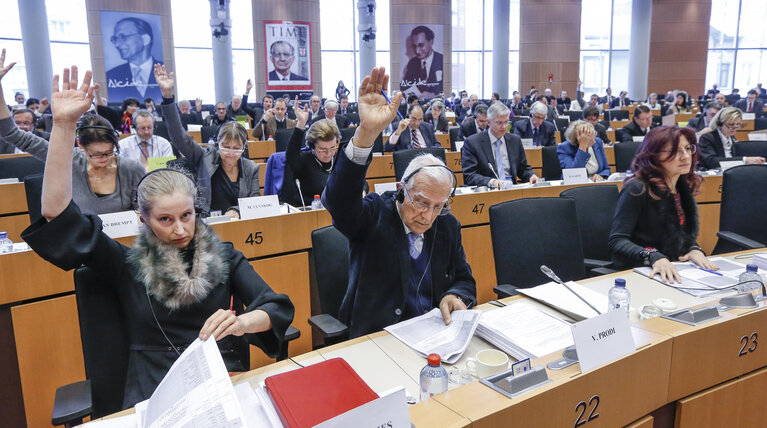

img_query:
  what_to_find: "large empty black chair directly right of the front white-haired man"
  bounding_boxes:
[489,198,586,298]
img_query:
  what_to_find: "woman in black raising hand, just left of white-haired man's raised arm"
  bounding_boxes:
[285,101,341,206]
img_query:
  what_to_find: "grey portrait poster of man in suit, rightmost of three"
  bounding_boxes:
[399,24,444,99]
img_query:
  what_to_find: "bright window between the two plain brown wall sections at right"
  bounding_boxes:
[580,0,631,99]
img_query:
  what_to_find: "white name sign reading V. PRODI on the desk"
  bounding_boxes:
[571,310,636,373]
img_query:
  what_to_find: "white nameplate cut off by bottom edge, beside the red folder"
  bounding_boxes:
[315,386,411,428]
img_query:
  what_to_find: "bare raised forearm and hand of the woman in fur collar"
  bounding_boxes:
[41,65,96,221]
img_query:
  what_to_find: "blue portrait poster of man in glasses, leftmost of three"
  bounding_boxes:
[100,10,163,103]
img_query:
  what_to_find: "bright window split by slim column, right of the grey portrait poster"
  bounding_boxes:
[446,0,519,98]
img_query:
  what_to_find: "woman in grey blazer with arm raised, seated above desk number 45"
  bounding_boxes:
[154,64,261,218]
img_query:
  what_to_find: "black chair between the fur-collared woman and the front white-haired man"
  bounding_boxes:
[309,226,349,345]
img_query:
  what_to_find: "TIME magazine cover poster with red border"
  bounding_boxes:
[264,21,312,93]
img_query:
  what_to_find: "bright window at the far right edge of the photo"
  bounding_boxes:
[706,0,767,96]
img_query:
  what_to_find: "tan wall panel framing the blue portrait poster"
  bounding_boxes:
[84,0,176,97]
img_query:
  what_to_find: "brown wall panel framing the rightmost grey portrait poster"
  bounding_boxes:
[390,0,450,94]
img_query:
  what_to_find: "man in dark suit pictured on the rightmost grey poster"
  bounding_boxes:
[400,25,443,98]
